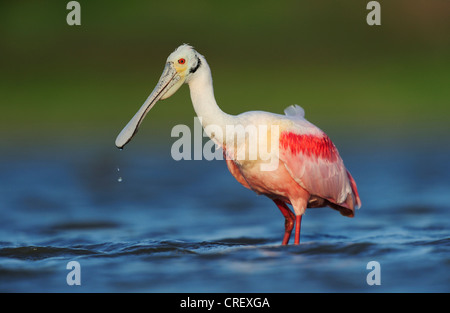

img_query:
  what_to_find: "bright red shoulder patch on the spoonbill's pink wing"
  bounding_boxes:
[280,132,339,162]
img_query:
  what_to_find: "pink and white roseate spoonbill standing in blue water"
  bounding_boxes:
[115,44,361,245]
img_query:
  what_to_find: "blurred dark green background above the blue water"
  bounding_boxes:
[0,0,450,145]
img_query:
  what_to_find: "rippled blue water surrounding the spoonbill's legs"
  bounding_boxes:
[0,138,450,292]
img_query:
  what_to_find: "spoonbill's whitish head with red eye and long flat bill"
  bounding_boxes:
[116,44,205,148]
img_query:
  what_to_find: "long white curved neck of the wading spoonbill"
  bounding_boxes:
[188,58,235,146]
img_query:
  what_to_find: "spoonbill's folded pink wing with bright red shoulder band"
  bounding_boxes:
[280,128,361,216]
